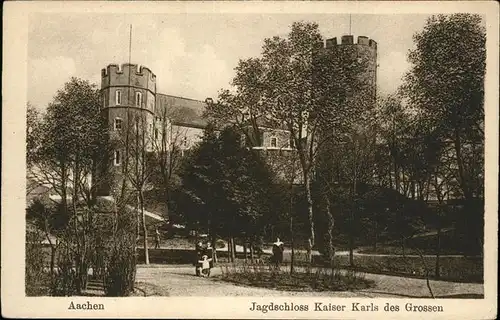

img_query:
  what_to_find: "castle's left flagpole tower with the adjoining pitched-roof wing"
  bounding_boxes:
[97,64,291,196]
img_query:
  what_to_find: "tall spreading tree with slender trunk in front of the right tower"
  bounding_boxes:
[206,22,375,262]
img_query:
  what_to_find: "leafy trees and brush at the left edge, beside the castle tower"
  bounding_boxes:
[27,78,135,296]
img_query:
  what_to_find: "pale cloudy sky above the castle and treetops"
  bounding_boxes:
[27,13,429,109]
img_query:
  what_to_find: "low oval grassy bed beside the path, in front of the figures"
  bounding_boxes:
[218,264,374,292]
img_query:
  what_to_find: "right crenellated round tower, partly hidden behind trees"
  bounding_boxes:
[315,35,377,186]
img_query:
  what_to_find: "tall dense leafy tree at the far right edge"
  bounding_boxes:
[402,14,486,255]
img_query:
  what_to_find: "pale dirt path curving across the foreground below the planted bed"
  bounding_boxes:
[136,265,483,298]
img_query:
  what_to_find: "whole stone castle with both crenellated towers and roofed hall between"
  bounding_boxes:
[99,35,377,195]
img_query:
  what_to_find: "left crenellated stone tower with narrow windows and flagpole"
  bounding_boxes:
[98,64,156,196]
